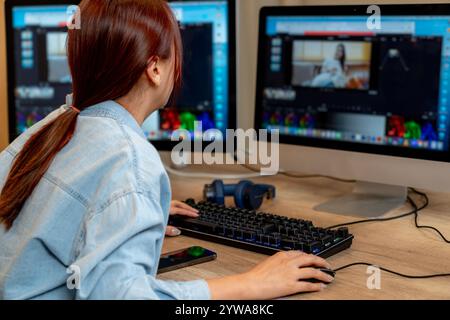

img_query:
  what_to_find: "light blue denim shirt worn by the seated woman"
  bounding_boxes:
[0,101,210,300]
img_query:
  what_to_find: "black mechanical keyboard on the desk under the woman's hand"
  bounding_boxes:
[169,199,353,258]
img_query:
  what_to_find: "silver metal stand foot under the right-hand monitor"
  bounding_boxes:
[314,181,408,218]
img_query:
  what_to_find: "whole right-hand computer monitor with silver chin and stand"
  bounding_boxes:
[255,4,450,216]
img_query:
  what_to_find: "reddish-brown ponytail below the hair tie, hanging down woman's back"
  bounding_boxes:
[0,108,79,230]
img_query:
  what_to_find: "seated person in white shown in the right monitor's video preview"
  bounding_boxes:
[311,43,347,88]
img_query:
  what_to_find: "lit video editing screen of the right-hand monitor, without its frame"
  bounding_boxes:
[260,16,450,152]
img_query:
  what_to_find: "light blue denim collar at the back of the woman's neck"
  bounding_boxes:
[80,100,147,140]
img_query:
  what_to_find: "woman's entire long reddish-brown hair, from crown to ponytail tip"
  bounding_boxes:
[0,0,182,229]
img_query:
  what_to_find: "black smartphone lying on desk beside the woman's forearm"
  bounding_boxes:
[158,246,217,274]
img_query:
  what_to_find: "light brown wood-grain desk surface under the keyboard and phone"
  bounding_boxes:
[161,167,450,299]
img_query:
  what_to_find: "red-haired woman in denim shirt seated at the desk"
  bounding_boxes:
[0,0,332,299]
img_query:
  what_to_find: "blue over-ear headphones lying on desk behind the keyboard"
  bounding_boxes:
[203,180,275,210]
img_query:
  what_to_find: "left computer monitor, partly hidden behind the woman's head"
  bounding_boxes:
[6,0,236,150]
